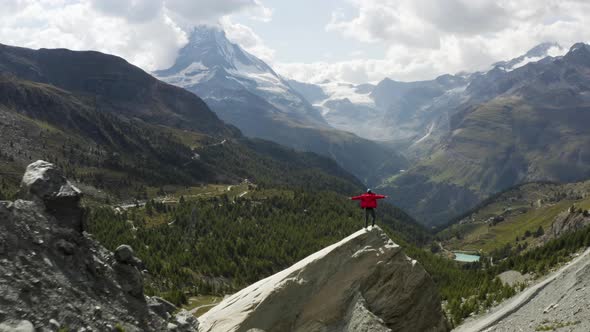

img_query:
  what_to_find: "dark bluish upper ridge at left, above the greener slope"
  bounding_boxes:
[0,45,237,137]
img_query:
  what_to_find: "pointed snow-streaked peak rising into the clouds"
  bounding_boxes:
[154,25,327,127]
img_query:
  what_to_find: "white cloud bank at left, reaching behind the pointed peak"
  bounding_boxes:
[0,0,272,70]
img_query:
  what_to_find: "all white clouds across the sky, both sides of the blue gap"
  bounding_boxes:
[0,0,590,83]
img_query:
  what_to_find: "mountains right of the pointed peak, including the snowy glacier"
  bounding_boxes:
[293,43,590,225]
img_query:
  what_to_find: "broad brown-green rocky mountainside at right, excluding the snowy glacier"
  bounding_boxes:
[384,44,590,224]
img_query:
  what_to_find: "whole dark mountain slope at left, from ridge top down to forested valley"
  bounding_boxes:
[0,41,362,198]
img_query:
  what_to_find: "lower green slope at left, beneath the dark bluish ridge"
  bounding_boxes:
[0,68,362,199]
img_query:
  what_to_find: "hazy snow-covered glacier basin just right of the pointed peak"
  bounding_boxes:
[290,75,469,151]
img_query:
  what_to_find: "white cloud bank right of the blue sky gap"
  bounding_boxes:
[284,0,590,83]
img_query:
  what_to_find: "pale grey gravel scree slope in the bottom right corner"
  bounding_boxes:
[454,249,590,332]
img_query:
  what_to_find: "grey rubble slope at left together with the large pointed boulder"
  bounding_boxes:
[0,161,449,332]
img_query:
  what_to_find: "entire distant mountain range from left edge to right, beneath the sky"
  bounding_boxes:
[0,27,590,231]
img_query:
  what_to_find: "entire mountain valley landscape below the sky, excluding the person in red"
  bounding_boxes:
[0,9,590,332]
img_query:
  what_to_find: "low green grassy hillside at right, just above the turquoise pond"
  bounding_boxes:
[438,182,590,253]
